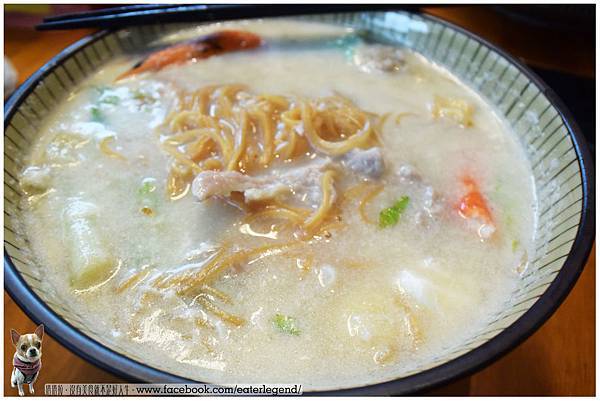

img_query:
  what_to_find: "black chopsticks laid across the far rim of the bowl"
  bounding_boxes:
[36,4,419,30]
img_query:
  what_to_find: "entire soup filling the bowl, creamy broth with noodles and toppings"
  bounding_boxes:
[20,20,536,390]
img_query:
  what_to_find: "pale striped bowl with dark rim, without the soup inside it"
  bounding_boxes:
[4,12,595,394]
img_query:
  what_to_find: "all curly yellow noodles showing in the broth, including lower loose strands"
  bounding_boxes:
[146,85,385,310]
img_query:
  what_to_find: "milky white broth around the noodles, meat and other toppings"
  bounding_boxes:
[20,21,536,390]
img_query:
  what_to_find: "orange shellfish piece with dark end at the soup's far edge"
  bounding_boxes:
[117,30,262,81]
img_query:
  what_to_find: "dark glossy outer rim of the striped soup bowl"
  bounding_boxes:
[4,11,595,395]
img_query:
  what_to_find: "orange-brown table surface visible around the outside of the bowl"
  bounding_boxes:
[4,7,596,395]
